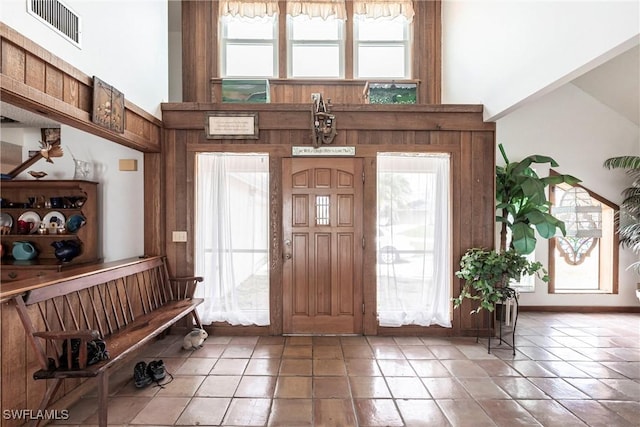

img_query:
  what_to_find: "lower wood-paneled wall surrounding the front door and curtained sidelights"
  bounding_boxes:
[163,103,495,335]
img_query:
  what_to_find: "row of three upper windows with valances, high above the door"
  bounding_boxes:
[219,0,413,79]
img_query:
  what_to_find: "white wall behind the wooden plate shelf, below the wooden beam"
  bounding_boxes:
[11,126,144,261]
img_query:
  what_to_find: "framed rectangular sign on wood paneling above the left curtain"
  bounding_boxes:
[205,111,259,139]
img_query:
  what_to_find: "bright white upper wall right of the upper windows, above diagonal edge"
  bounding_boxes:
[442,0,640,121]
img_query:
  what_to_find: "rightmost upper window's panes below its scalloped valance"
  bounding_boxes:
[353,15,411,79]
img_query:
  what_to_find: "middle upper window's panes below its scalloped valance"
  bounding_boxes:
[287,15,344,78]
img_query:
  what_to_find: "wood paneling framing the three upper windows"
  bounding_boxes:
[182,0,441,104]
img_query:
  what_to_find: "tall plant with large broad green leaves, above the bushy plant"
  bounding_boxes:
[496,144,580,255]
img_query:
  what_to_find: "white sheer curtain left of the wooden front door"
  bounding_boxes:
[195,153,269,325]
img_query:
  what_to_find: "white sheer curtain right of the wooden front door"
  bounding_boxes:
[377,153,452,327]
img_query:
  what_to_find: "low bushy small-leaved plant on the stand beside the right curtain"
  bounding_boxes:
[453,248,549,313]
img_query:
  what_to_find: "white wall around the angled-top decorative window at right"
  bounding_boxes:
[496,84,640,306]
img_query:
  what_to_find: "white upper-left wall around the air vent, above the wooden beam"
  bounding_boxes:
[0,0,169,118]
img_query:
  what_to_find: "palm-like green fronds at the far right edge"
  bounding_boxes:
[604,156,640,274]
